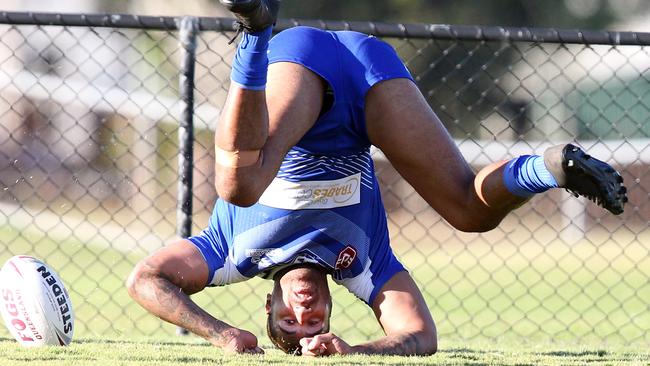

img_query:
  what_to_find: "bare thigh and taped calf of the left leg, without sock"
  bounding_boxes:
[215,62,324,206]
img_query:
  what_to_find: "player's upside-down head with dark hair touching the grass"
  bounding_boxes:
[266,266,332,354]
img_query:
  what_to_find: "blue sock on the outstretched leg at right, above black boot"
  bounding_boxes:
[503,155,558,198]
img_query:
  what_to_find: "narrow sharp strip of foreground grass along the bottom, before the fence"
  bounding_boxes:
[0,338,650,366]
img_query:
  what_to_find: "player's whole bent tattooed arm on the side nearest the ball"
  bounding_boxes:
[127,240,262,353]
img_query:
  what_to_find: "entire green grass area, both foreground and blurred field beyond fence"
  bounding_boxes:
[0,213,650,365]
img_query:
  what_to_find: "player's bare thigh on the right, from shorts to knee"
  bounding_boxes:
[366,79,474,216]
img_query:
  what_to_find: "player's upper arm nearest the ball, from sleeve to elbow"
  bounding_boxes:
[136,239,208,294]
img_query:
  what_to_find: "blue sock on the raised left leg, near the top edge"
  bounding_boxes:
[230,26,273,90]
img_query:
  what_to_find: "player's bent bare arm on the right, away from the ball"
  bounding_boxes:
[301,271,438,356]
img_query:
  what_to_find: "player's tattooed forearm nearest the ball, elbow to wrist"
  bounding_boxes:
[134,264,232,346]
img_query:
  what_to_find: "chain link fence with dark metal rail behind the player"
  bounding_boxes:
[0,13,650,344]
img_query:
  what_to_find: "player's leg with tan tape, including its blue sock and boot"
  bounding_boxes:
[215,0,324,206]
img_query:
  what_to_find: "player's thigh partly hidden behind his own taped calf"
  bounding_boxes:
[265,62,325,154]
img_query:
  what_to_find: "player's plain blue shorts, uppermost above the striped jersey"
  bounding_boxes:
[268,27,413,154]
